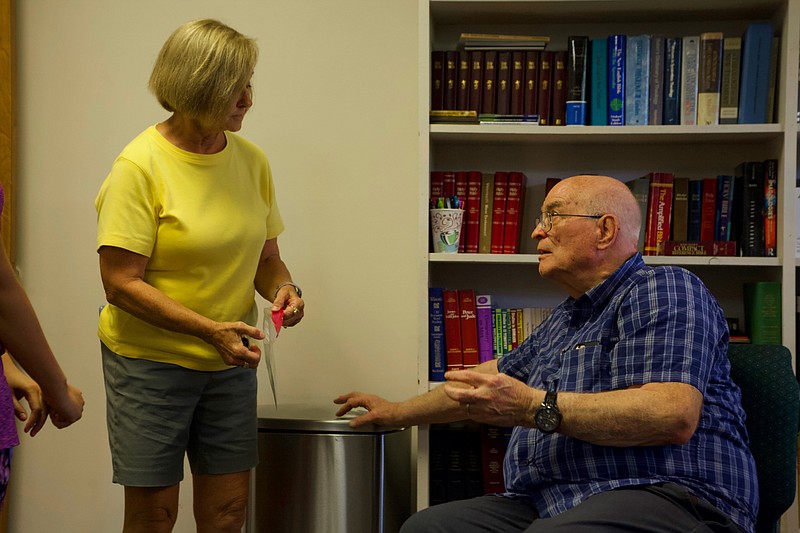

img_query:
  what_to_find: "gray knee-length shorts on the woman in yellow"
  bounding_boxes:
[101,343,258,487]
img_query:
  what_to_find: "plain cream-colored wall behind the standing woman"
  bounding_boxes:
[10,0,424,533]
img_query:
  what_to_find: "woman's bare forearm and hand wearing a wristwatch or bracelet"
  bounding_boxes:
[255,238,305,327]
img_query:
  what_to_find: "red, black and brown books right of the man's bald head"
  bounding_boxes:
[628,159,778,257]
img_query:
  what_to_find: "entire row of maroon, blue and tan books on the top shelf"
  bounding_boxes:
[431,22,779,126]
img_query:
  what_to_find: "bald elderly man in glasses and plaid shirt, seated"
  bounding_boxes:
[335,176,758,533]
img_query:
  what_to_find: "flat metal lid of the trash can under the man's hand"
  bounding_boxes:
[258,403,405,434]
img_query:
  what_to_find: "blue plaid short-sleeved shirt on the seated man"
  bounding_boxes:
[498,254,758,531]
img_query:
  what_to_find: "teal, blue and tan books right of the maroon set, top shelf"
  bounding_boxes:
[592,23,779,126]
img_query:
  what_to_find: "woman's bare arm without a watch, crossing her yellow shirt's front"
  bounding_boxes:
[98,246,263,367]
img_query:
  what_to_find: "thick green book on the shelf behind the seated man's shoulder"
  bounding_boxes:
[744,281,783,344]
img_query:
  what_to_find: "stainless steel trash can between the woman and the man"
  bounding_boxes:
[247,404,412,533]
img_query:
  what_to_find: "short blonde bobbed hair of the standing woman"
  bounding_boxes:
[148,19,258,122]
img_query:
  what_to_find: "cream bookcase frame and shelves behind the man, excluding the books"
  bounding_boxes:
[417,0,800,533]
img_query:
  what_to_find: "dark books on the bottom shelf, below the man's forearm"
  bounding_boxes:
[429,423,511,505]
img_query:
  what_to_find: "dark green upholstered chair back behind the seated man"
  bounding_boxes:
[728,344,800,533]
